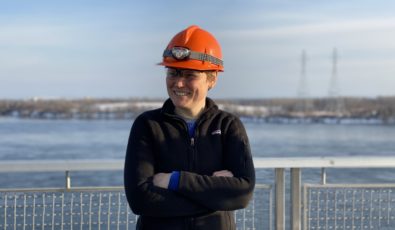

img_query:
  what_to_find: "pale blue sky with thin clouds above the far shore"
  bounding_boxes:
[0,0,395,98]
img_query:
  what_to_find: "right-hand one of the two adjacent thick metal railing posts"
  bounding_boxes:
[291,168,302,230]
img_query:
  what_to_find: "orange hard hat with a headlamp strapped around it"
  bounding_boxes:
[159,25,224,71]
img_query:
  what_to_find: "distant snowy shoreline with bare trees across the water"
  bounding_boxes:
[0,96,395,123]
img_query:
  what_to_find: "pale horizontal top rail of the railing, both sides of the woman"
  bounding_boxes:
[0,156,395,172]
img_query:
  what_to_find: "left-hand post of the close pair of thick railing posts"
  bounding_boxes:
[275,168,285,230]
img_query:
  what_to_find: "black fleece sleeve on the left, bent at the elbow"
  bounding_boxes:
[124,117,208,217]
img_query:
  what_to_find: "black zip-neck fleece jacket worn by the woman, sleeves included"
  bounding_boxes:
[124,98,255,230]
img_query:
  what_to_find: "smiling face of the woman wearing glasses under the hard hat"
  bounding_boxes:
[166,68,216,114]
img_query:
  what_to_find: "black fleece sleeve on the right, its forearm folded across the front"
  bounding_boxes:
[177,118,255,210]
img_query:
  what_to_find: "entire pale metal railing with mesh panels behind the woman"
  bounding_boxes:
[0,157,395,230]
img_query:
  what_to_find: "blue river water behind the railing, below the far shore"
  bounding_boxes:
[0,118,395,187]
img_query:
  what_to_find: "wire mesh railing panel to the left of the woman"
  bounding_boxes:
[0,188,136,230]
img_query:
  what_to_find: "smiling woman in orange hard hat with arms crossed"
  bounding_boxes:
[124,26,255,230]
